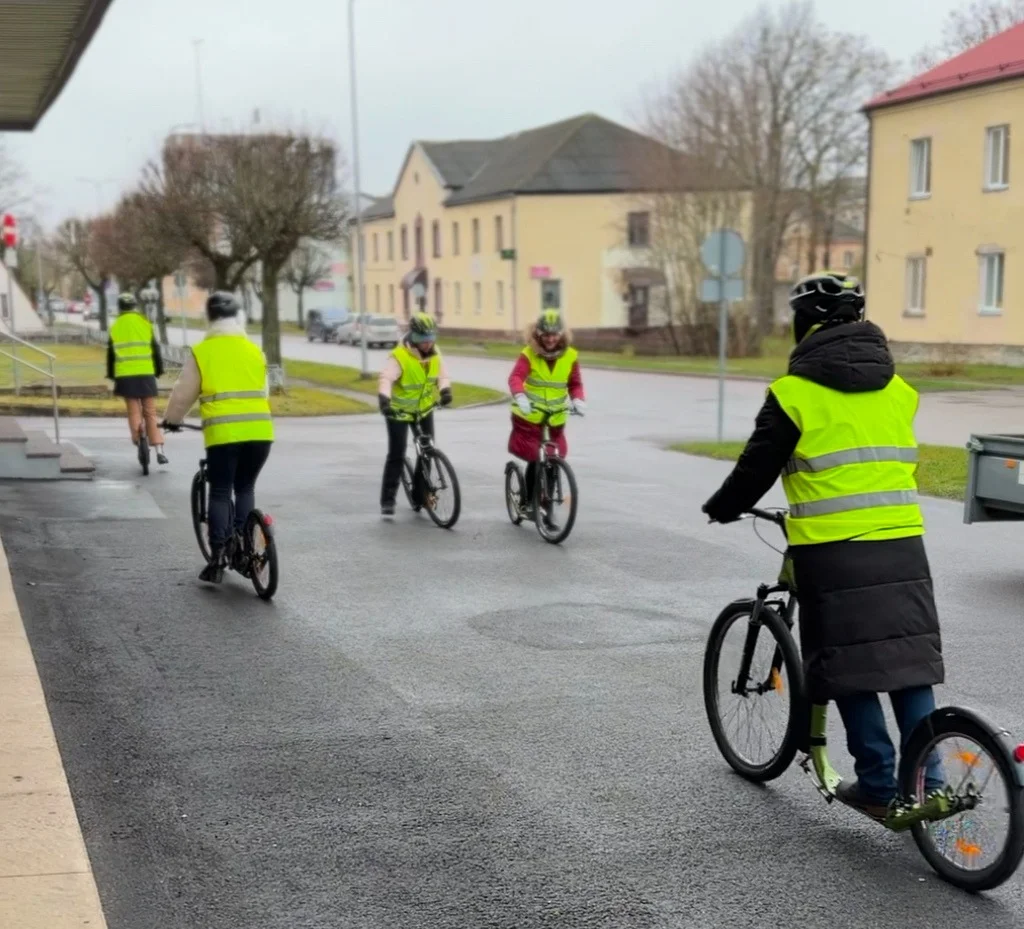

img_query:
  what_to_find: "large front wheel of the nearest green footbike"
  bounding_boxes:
[703,600,806,784]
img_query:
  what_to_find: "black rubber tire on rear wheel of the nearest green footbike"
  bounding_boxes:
[900,707,1024,893]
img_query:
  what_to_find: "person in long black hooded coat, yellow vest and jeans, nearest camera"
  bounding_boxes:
[703,271,944,819]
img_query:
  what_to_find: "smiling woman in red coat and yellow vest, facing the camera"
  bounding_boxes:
[508,309,587,517]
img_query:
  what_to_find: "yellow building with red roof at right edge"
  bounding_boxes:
[864,24,1024,364]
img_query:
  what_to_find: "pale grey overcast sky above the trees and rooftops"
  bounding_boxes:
[7,0,959,225]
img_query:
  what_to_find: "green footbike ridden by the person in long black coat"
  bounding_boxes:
[703,509,1024,892]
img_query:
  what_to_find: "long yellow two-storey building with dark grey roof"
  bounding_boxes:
[362,114,724,337]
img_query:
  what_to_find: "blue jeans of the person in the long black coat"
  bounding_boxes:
[836,687,945,803]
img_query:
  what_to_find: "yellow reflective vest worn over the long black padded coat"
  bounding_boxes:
[769,375,924,545]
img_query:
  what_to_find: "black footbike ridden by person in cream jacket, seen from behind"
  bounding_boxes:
[171,423,279,600]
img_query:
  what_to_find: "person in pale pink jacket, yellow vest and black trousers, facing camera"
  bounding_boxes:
[377,312,452,517]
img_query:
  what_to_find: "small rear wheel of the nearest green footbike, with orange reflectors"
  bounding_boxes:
[900,707,1024,892]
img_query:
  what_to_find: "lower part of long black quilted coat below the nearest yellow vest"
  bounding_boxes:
[790,536,944,703]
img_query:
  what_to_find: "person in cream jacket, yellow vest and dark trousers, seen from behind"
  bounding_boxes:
[164,292,273,584]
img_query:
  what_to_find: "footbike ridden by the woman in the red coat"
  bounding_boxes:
[505,407,581,545]
